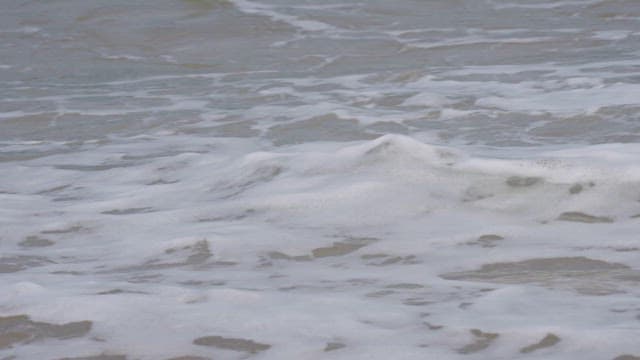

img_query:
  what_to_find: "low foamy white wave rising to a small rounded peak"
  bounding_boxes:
[211,135,640,222]
